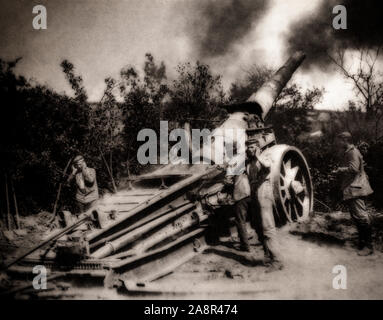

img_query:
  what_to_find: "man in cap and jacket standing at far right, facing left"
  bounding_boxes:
[333,132,374,256]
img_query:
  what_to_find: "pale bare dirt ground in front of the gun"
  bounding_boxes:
[0,212,383,299]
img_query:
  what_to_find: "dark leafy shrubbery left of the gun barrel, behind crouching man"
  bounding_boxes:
[0,54,226,214]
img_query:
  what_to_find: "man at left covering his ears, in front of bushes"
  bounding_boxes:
[68,155,98,214]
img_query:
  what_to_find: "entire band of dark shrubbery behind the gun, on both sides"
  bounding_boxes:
[0,54,383,218]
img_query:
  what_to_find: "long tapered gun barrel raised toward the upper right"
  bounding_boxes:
[246,51,306,120]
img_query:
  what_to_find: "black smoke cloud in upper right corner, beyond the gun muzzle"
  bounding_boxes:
[287,0,383,67]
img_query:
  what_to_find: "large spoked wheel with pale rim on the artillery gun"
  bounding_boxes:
[266,145,313,222]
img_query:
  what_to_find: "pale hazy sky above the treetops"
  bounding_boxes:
[0,0,353,109]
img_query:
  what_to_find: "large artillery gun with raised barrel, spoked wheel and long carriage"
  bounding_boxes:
[7,52,313,291]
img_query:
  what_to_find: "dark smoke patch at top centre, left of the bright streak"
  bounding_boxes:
[193,0,269,58]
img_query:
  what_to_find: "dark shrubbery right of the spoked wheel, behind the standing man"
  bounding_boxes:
[273,110,383,210]
